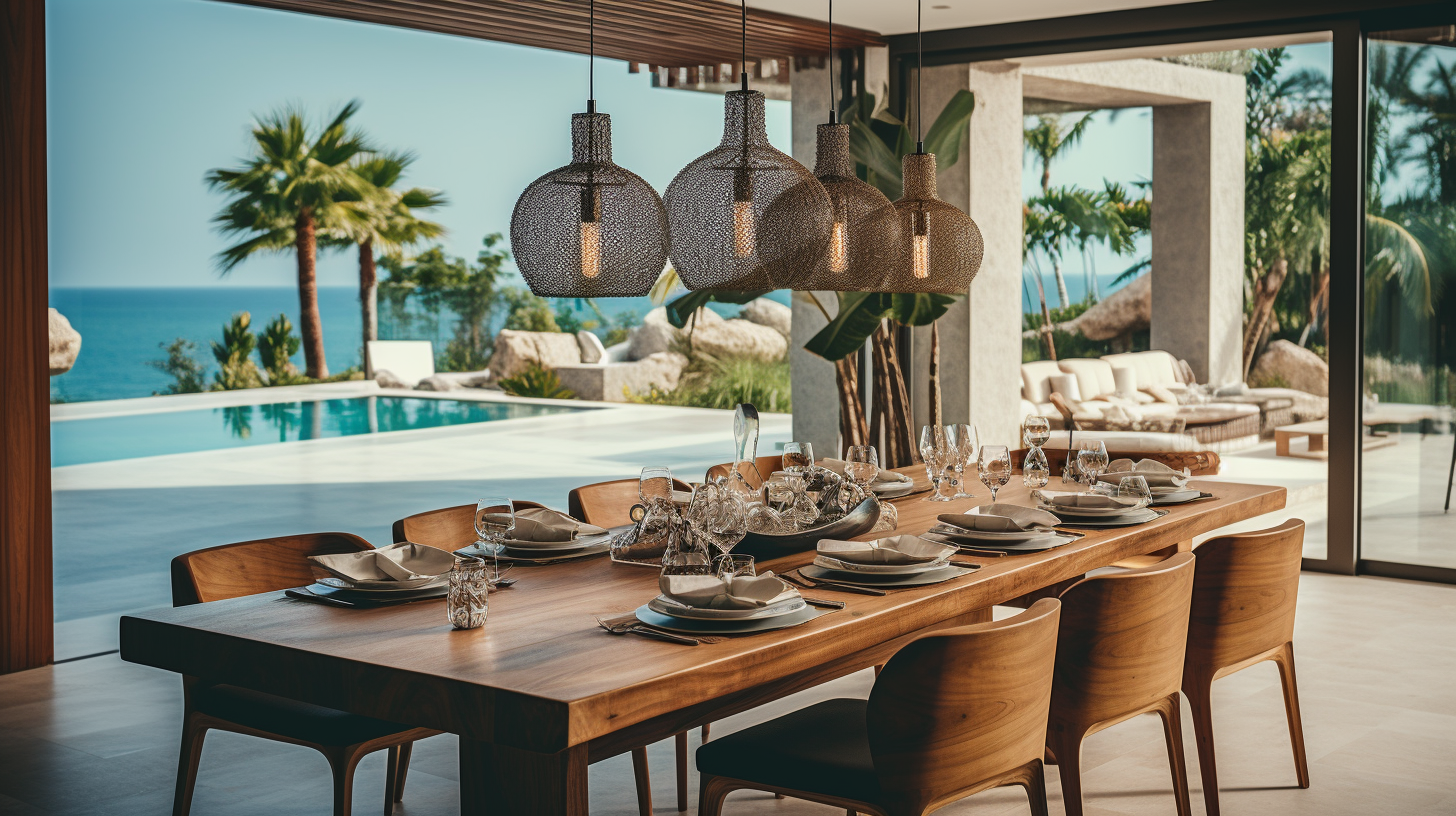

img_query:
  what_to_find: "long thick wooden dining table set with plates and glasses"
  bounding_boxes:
[121,469,1286,816]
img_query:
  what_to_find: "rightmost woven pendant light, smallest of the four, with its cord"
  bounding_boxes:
[884,0,984,294]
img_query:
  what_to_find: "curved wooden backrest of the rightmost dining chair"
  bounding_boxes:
[1187,519,1305,669]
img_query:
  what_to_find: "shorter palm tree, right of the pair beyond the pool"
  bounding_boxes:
[329,153,447,377]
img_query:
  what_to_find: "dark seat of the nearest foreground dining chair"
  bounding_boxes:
[697,699,879,804]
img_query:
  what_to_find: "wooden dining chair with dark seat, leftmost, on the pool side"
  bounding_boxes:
[172,533,440,816]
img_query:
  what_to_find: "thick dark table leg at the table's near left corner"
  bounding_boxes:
[460,737,588,816]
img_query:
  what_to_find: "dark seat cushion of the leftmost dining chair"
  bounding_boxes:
[192,685,412,746]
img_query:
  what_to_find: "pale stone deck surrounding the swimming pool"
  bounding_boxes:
[51,382,791,660]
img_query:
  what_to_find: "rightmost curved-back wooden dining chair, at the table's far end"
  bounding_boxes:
[1182,519,1309,816]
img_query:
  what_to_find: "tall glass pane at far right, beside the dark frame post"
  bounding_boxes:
[1360,28,1456,568]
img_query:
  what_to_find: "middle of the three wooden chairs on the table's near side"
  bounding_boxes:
[1047,552,1194,816]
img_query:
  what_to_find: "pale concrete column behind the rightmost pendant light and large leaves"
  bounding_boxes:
[906,63,1022,447]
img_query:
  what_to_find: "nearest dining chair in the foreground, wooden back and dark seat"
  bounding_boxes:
[697,597,1061,816]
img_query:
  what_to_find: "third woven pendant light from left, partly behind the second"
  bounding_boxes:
[792,0,900,291]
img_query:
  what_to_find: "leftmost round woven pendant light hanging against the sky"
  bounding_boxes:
[511,0,667,297]
